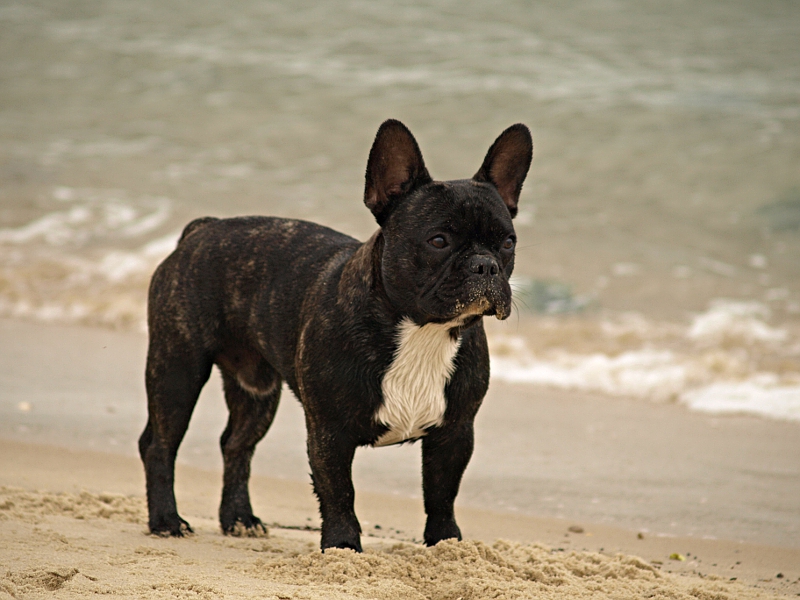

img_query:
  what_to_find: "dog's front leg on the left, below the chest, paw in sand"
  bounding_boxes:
[308,422,361,552]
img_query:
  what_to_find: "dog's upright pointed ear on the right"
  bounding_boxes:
[472,123,533,218]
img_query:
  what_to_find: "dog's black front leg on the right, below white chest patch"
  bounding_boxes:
[422,422,474,546]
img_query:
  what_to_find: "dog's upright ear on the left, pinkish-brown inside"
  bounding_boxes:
[364,119,433,226]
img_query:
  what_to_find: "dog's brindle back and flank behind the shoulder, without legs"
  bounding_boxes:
[148,217,359,377]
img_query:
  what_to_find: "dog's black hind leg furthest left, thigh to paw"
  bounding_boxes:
[139,344,212,536]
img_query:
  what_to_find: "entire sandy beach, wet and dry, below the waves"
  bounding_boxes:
[0,321,800,598]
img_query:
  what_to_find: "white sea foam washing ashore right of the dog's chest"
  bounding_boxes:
[490,299,800,421]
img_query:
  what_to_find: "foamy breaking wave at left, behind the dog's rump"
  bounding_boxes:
[0,186,179,329]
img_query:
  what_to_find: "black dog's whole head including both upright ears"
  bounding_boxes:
[364,120,533,325]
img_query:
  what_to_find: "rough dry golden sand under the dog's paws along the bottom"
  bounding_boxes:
[0,442,800,600]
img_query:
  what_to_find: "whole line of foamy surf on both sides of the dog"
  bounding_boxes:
[0,186,800,420]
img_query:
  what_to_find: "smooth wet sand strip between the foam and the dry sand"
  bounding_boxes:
[0,320,800,547]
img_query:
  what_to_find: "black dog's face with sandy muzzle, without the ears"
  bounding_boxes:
[382,180,516,324]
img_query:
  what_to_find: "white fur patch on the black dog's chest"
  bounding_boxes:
[374,319,461,446]
